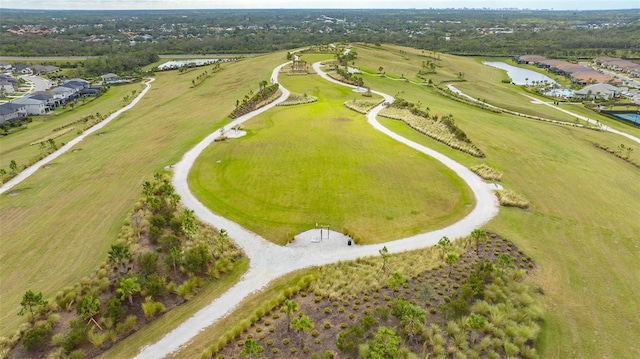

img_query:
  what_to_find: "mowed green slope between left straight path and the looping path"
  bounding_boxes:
[0,53,285,335]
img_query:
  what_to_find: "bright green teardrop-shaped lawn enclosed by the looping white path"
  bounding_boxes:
[189,71,474,244]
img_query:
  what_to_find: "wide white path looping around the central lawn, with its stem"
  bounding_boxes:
[136,63,498,358]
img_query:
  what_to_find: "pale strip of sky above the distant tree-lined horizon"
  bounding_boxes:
[0,0,640,10]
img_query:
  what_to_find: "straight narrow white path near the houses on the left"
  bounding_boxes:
[0,78,156,194]
